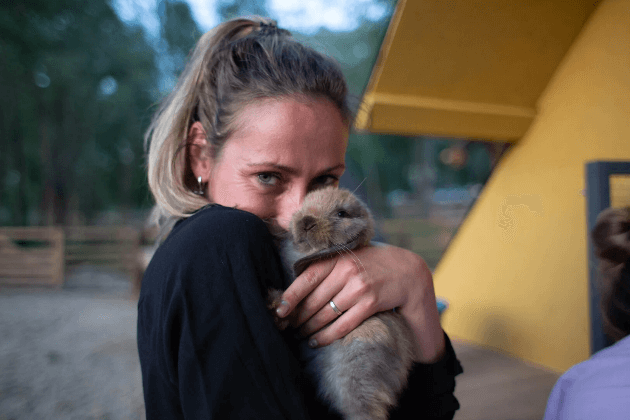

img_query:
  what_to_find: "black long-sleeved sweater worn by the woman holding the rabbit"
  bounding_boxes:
[138,205,462,420]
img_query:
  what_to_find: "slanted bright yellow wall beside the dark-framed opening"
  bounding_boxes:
[435,0,630,370]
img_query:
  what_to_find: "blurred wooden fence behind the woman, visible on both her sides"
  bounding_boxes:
[0,219,454,293]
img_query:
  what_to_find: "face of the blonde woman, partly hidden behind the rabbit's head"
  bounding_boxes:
[199,98,348,230]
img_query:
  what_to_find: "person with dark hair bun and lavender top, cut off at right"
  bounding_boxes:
[545,208,630,420]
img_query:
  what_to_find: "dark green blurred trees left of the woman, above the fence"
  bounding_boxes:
[0,0,157,225]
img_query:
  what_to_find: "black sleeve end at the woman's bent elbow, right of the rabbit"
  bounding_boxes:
[390,333,464,420]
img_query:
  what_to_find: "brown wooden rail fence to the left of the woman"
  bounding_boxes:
[0,226,140,287]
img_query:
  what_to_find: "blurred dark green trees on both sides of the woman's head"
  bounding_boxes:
[0,0,498,225]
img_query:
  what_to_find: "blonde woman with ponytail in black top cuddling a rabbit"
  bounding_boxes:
[138,18,461,420]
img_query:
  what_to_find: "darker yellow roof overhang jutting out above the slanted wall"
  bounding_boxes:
[355,0,597,141]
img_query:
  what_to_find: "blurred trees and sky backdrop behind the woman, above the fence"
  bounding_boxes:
[0,0,504,267]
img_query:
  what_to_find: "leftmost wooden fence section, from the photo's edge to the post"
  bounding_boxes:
[0,227,64,287]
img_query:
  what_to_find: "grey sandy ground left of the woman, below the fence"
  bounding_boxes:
[0,268,145,420]
